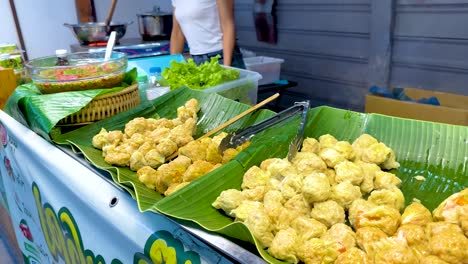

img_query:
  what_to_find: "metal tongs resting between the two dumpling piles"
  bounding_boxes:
[218,101,309,160]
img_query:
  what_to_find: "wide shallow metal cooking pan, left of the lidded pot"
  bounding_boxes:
[64,22,133,45]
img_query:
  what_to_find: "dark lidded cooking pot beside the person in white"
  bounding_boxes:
[137,6,172,40]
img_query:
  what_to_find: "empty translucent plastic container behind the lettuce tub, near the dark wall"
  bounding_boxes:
[244,56,284,85]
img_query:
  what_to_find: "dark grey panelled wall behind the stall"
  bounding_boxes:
[235,0,468,111]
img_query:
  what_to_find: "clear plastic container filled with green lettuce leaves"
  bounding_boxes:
[201,66,262,105]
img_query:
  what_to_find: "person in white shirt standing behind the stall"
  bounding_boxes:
[170,0,245,69]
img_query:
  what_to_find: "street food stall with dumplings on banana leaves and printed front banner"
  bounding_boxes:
[0,1,468,264]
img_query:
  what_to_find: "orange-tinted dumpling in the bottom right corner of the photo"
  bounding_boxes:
[426,222,468,264]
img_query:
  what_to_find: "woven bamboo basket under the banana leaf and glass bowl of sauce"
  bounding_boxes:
[57,83,140,126]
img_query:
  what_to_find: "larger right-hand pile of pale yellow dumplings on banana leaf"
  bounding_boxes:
[212,134,468,263]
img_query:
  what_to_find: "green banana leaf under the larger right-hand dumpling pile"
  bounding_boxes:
[156,107,468,263]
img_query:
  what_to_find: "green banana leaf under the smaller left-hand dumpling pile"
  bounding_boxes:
[53,88,274,211]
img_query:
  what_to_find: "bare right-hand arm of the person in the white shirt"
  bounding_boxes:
[217,0,236,66]
